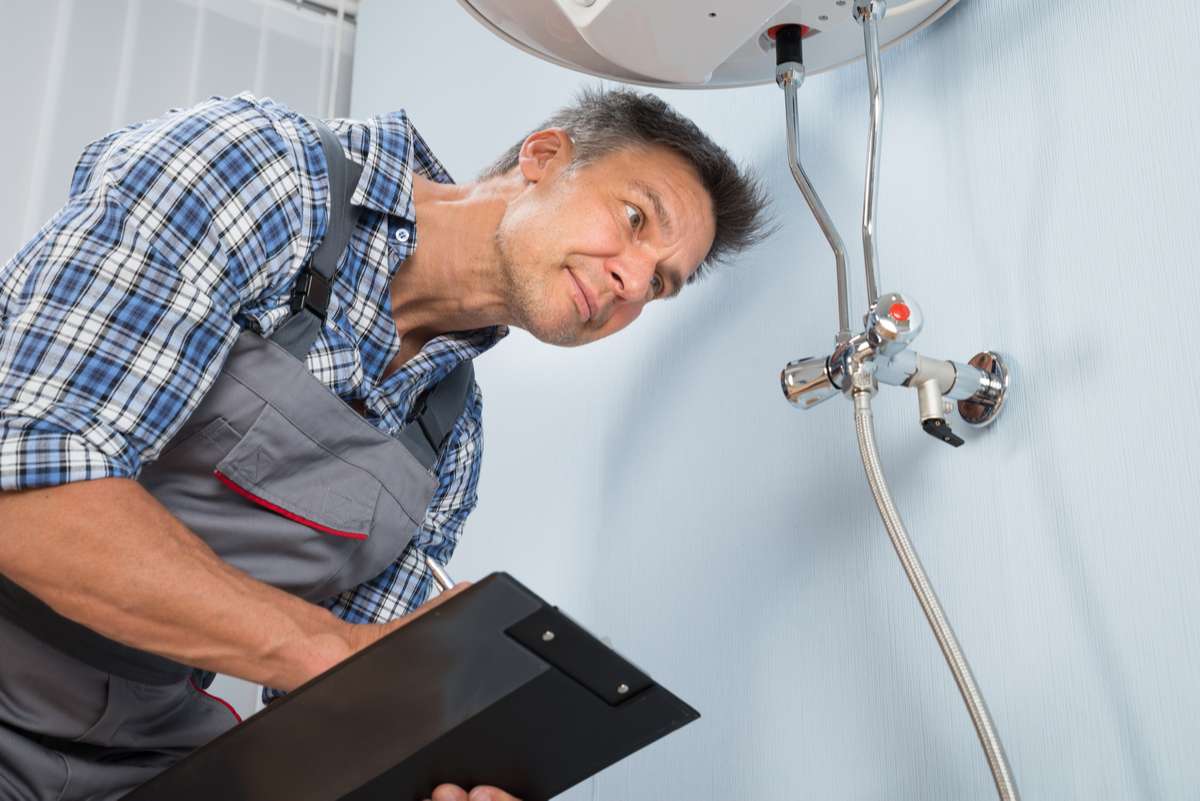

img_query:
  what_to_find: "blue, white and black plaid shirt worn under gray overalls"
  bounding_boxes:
[0,95,506,622]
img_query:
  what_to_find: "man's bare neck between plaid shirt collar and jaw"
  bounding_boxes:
[384,175,508,375]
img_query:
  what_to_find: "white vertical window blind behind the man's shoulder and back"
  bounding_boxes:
[0,0,358,264]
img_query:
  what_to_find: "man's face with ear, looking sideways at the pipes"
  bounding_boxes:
[497,131,715,345]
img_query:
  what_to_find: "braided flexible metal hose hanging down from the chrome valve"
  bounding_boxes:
[854,391,1020,801]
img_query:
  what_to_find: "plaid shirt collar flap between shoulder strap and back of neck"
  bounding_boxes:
[349,112,454,223]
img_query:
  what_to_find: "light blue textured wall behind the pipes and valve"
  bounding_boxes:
[352,0,1200,801]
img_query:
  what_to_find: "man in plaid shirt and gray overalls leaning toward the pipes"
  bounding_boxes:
[0,91,763,801]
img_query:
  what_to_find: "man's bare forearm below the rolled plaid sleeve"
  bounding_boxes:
[0,478,355,689]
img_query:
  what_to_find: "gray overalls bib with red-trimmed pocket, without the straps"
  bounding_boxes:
[139,362,437,601]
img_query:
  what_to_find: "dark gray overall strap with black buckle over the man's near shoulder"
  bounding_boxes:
[271,120,362,359]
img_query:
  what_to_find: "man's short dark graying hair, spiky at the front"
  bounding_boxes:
[480,89,773,279]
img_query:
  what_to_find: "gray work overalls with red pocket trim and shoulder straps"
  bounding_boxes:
[0,124,473,801]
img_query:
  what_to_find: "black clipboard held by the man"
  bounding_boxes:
[124,573,700,801]
